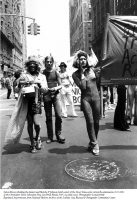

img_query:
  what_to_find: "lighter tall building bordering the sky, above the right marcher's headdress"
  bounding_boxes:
[69,0,92,56]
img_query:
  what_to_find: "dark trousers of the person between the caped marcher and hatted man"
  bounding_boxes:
[44,94,62,140]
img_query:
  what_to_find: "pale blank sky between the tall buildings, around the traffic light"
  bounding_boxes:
[26,0,70,61]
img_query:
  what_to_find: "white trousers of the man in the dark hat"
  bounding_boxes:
[61,86,76,116]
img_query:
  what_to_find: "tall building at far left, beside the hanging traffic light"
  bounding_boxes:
[0,0,25,76]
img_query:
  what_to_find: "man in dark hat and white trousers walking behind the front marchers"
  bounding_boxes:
[59,62,78,118]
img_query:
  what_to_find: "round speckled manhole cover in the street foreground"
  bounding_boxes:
[65,158,137,182]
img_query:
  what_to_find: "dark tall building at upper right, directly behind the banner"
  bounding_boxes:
[90,0,137,59]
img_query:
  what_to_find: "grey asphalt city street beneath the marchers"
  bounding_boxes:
[0,90,137,189]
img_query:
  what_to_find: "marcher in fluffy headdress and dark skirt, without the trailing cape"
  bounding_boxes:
[19,57,47,153]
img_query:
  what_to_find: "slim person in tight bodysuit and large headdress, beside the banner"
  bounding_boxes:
[72,50,100,155]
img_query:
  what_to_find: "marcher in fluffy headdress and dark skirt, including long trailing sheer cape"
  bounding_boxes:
[5,57,47,153]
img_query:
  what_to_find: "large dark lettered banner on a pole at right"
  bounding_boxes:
[101,16,137,85]
